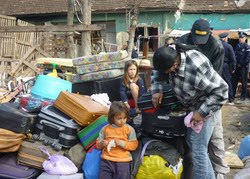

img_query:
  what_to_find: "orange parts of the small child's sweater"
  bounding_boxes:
[97,125,138,162]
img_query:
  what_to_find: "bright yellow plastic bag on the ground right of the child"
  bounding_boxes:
[136,155,183,179]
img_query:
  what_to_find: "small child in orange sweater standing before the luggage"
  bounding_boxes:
[96,101,138,179]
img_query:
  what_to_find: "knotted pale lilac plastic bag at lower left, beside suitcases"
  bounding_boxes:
[40,148,78,175]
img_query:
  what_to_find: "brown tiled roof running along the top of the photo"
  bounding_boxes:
[0,0,250,16]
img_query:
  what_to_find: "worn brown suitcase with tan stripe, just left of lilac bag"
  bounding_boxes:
[17,141,64,169]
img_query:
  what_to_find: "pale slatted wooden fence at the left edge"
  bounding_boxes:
[0,15,41,87]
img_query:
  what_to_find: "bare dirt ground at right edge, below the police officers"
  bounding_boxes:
[222,100,250,179]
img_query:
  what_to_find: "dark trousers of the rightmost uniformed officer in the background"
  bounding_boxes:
[232,66,248,100]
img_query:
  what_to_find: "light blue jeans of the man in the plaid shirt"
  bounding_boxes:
[186,111,219,179]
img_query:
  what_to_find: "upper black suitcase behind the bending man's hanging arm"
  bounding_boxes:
[137,84,181,111]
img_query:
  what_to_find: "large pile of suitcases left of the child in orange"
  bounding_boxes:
[0,91,108,179]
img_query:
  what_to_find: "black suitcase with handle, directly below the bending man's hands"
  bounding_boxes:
[141,108,187,139]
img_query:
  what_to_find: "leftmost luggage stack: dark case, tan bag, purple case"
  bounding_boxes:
[0,103,41,179]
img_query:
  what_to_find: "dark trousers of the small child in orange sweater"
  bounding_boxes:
[99,159,130,179]
